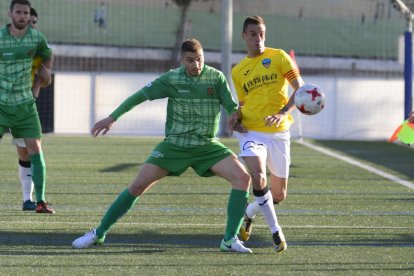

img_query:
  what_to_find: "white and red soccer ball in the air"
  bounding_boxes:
[295,83,325,115]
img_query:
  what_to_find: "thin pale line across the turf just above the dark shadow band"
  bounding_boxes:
[0,221,414,230]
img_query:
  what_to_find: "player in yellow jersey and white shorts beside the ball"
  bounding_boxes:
[229,16,303,252]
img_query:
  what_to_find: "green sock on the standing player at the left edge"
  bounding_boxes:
[30,152,46,202]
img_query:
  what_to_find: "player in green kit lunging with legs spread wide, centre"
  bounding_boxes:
[72,39,252,253]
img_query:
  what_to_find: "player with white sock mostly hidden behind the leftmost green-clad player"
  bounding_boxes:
[13,7,51,211]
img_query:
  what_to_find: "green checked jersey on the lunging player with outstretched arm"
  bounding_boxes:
[111,65,237,148]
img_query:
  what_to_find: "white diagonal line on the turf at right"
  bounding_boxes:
[297,140,414,190]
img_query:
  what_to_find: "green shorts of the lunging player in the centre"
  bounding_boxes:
[145,141,234,177]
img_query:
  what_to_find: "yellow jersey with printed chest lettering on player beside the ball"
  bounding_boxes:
[232,48,300,132]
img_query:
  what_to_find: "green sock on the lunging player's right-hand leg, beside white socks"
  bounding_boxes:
[224,189,249,241]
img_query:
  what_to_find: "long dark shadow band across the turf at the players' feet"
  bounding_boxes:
[0,229,414,254]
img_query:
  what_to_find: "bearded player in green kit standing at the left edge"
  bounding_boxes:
[0,0,55,214]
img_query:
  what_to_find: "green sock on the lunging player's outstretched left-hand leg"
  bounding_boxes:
[96,189,138,238]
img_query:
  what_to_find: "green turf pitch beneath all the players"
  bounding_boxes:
[0,135,414,275]
